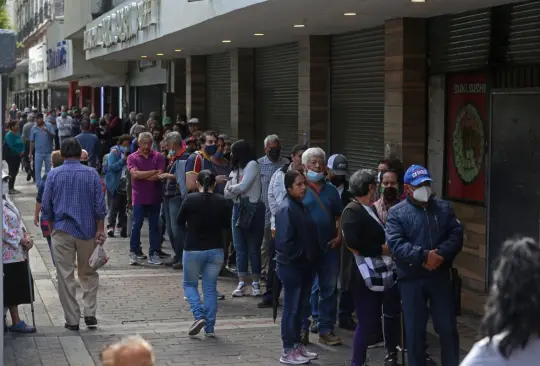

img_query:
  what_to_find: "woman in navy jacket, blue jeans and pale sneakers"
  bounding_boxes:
[275,169,321,365]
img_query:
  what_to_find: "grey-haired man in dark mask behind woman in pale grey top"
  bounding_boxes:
[257,135,289,273]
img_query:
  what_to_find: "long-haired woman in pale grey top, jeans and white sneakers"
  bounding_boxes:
[225,140,265,297]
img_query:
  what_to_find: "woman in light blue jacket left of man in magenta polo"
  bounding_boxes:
[105,135,131,238]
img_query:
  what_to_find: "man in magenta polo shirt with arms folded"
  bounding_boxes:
[127,132,165,265]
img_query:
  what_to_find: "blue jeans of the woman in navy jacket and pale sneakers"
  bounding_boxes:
[276,263,313,352]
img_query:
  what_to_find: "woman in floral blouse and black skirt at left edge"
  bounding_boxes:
[2,172,36,333]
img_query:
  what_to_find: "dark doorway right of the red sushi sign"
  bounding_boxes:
[487,90,540,282]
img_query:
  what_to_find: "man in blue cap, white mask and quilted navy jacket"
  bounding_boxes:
[386,165,463,366]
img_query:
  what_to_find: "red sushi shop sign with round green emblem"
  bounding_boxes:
[446,74,488,202]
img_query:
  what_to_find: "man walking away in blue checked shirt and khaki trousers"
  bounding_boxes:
[41,138,107,330]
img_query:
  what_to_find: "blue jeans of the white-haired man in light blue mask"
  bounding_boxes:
[302,249,339,334]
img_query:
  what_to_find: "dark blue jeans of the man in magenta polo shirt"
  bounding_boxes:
[129,203,161,256]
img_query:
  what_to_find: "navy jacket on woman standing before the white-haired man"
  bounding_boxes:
[275,195,321,267]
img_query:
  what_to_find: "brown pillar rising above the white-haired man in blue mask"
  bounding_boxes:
[298,36,330,150]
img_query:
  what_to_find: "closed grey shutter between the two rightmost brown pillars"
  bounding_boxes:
[331,27,385,172]
